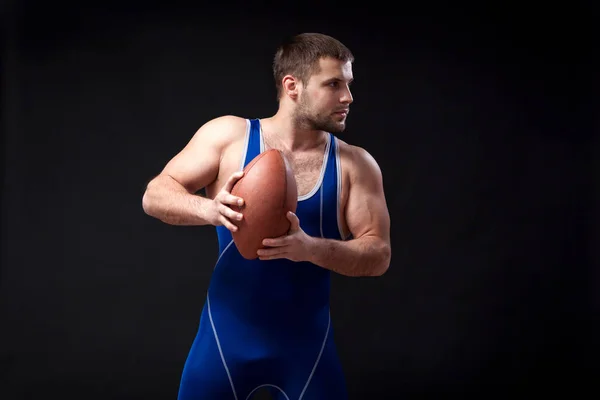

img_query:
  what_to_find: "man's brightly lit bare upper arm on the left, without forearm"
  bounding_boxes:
[161,117,244,193]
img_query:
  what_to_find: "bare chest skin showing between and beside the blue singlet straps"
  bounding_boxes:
[206,117,349,236]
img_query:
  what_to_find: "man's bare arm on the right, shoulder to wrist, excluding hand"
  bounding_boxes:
[309,148,391,276]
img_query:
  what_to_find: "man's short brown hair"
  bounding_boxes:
[273,33,354,99]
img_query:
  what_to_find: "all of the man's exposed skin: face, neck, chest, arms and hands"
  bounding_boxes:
[142,58,391,276]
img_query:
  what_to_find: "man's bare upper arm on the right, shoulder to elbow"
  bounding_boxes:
[345,149,390,242]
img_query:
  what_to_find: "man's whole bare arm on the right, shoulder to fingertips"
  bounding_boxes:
[258,147,391,276]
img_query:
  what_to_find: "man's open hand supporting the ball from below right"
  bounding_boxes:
[257,211,314,261]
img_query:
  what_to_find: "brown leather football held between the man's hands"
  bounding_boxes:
[231,149,298,260]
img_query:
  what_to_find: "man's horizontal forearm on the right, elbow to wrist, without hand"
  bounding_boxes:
[309,236,391,276]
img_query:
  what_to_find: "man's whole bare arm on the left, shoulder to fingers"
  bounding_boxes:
[142,116,246,229]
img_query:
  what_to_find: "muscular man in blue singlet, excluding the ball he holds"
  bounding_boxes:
[143,34,391,400]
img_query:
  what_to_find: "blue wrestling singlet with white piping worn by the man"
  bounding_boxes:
[178,119,347,400]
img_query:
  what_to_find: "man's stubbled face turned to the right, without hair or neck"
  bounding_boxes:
[295,58,353,133]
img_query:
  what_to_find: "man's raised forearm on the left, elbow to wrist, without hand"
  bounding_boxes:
[142,176,214,225]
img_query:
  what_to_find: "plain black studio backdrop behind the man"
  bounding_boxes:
[0,1,600,400]
